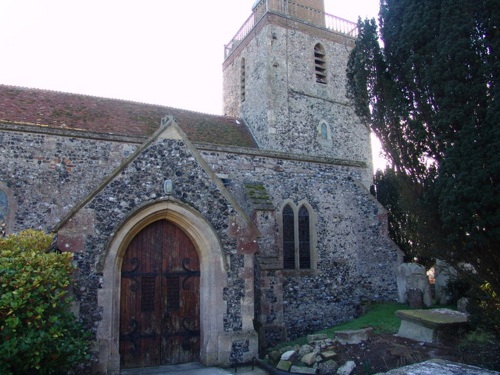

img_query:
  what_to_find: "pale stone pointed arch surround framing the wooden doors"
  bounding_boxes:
[95,199,227,374]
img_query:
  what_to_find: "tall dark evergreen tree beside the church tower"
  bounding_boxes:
[347,0,500,294]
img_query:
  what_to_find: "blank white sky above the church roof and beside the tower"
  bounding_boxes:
[0,0,379,169]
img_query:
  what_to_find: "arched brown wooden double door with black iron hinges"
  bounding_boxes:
[120,220,200,368]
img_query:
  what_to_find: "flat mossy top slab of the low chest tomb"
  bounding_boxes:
[395,309,468,329]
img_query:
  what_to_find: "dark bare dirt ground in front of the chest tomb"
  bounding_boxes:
[335,334,500,375]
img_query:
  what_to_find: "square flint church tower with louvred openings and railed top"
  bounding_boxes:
[223,0,372,186]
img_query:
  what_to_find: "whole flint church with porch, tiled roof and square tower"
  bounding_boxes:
[0,0,401,374]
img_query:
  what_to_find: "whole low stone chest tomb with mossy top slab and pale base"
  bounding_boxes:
[396,309,468,343]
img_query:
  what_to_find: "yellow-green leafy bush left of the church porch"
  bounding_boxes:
[0,230,89,375]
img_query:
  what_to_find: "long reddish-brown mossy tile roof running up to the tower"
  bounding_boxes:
[0,85,257,148]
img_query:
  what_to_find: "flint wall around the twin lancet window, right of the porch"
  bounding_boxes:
[202,150,401,338]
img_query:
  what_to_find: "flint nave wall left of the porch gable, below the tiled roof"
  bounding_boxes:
[0,129,139,232]
